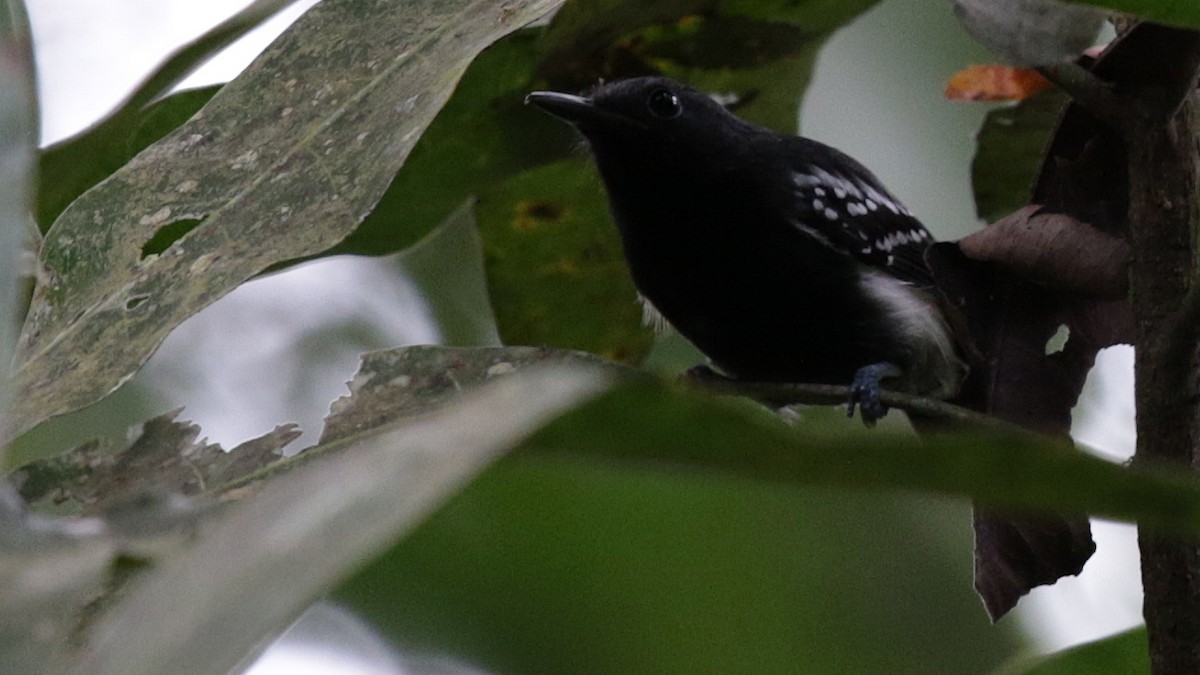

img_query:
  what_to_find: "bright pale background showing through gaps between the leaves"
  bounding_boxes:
[26,0,1141,662]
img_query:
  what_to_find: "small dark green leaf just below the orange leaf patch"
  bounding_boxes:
[971,89,1067,222]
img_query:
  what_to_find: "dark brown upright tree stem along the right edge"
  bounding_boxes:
[1115,24,1200,675]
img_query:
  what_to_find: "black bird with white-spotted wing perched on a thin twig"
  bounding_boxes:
[526,77,966,424]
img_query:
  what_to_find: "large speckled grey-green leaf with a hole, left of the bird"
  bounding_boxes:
[10,0,553,441]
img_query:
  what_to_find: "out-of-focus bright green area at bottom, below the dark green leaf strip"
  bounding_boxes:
[343,456,1016,675]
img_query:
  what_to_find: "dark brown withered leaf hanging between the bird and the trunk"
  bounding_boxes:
[929,233,1132,620]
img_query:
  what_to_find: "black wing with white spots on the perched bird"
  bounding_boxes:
[790,149,934,286]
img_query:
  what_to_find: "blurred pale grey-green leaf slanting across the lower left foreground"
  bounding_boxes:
[77,368,605,675]
